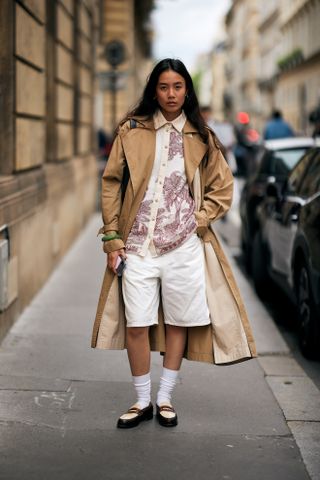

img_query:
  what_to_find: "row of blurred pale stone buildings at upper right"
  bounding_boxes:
[222,0,320,134]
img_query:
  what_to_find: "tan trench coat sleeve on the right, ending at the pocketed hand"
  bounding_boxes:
[195,136,233,235]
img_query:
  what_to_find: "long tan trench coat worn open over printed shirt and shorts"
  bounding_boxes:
[91,117,257,365]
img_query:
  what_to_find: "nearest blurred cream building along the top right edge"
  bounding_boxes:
[275,0,320,133]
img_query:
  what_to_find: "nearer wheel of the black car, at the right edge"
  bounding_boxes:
[297,264,319,359]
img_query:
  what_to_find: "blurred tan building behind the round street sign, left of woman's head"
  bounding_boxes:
[96,0,154,135]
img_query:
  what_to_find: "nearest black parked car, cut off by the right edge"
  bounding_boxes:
[252,147,320,358]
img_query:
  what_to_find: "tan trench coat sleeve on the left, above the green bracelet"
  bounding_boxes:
[99,129,125,253]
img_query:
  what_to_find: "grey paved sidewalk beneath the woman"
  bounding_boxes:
[0,216,320,480]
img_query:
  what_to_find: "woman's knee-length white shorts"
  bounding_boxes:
[122,234,210,327]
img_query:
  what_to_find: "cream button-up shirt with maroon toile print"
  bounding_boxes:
[126,110,197,256]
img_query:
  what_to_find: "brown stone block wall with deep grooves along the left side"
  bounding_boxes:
[0,0,101,338]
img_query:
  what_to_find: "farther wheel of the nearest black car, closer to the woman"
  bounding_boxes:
[251,232,270,298]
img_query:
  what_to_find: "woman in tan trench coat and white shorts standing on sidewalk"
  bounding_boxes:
[92,59,256,428]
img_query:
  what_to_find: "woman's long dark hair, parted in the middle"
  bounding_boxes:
[121,58,208,142]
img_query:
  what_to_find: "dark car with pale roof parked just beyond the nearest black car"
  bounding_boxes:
[240,137,314,271]
